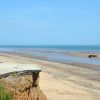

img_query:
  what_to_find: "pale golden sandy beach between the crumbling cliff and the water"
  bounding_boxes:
[0,53,100,100]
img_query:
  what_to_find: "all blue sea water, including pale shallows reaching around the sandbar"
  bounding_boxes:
[0,46,100,67]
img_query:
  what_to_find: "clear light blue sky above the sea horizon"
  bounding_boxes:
[0,0,100,45]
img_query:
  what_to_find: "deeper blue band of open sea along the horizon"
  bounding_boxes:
[0,45,100,52]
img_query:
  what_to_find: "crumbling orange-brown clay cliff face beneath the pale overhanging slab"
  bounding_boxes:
[2,73,46,100]
